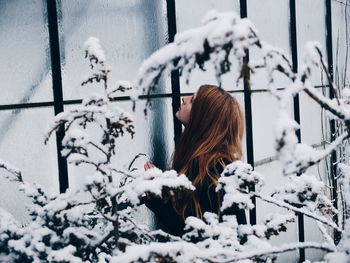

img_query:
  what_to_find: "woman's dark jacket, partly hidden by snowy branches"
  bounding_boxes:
[143,161,247,236]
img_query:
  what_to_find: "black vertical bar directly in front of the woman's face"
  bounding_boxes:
[166,0,182,143]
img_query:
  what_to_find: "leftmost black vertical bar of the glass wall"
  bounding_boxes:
[47,0,68,193]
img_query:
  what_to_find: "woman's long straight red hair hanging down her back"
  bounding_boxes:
[172,85,244,218]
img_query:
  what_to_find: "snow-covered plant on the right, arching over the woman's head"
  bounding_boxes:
[124,11,350,262]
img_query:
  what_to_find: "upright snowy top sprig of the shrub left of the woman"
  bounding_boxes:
[46,37,135,171]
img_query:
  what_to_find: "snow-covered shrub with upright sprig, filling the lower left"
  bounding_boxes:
[0,38,193,263]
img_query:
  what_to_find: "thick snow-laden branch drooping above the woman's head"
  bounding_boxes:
[137,11,259,97]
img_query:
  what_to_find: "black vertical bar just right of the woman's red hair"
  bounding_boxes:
[240,0,256,225]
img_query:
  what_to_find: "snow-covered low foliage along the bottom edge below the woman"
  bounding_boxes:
[111,212,298,262]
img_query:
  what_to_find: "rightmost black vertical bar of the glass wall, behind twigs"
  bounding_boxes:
[326,0,340,244]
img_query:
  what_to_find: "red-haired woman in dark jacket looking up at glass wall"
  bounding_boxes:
[144,85,246,235]
